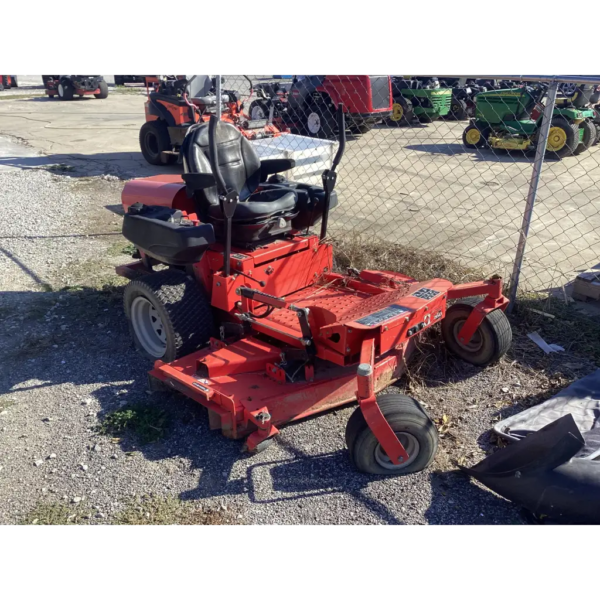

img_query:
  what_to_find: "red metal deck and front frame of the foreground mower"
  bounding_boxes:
[120,238,506,450]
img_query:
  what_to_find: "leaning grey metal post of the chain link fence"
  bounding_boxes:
[508,81,559,313]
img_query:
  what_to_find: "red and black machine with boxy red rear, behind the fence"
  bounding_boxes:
[249,74,392,139]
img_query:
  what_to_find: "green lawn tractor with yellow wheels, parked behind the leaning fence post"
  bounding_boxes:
[463,84,596,158]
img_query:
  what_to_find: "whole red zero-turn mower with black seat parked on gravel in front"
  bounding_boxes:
[117,107,512,475]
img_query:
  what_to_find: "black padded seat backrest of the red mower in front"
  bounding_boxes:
[183,121,261,208]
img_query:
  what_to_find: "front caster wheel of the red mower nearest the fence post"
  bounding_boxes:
[442,298,512,367]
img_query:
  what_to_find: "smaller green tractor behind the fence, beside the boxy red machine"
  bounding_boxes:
[387,77,452,126]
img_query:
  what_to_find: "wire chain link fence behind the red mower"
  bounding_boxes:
[221,74,600,302]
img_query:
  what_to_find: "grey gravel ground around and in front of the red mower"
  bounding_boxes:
[0,138,591,525]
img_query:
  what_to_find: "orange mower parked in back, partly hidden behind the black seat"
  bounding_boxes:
[140,74,281,165]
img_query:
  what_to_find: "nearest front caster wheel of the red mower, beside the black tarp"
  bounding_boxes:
[346,394,439,476]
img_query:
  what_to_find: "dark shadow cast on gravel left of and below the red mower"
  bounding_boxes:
[0,287,528,525]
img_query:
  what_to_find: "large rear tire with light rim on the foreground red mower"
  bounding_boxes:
[125,270,215,363]
